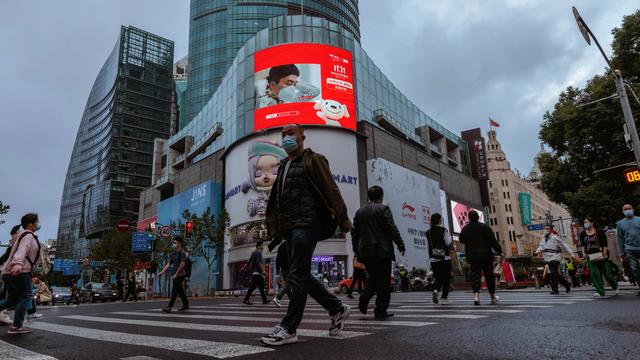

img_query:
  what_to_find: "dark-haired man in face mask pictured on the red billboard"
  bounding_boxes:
[256,64,320,109]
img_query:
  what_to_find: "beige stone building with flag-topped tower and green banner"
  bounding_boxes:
[486,130,576,257]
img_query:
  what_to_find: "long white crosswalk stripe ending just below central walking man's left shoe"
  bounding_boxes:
[31,322,273,359]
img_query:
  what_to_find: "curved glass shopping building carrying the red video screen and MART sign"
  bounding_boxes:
[139,13,482,289]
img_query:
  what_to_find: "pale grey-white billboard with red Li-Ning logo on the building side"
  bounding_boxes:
[367,159,442,269]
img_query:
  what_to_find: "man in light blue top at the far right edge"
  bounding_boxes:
[616,204,640,296]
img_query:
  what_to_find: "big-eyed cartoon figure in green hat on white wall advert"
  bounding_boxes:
[242,140,287,217]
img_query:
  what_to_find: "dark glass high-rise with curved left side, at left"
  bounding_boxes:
[56,26,173,258]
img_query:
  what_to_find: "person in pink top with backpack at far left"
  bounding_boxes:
[0,213,40,334]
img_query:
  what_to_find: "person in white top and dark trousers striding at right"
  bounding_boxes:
[536,224,577,295]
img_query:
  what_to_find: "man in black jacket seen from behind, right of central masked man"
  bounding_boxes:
[351,186,405,319]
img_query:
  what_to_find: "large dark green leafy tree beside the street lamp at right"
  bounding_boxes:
[539,11,640,224]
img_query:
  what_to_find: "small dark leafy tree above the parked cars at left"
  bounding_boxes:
[90,231,136,273]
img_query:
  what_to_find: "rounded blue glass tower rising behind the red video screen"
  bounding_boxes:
[180,0,360,129]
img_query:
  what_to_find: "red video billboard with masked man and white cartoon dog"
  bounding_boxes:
[254,43,356,131]
